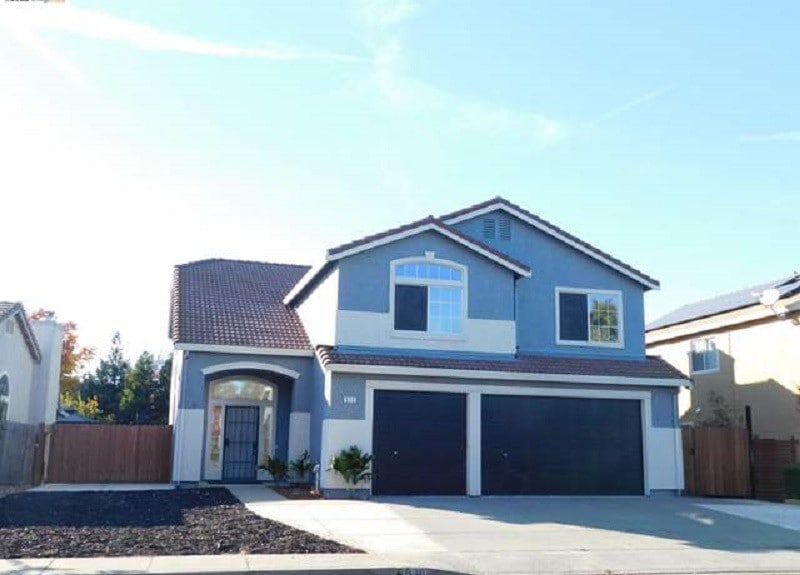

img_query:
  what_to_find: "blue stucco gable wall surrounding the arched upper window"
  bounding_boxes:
[339,232,514,320]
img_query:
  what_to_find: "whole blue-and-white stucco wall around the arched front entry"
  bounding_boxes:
[173,351,314,482]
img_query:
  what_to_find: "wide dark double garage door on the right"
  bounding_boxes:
[481,395,644,495]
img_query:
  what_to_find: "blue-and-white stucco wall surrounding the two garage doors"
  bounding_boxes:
[320,373,683,494]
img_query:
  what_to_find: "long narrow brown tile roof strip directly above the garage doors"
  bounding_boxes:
[317,346,688,380]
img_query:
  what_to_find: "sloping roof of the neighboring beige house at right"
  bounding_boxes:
[647,273,800,331]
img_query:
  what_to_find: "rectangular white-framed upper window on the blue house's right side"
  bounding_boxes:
[556,287,625,347]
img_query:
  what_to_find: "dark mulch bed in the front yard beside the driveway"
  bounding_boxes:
[0,488,361,559]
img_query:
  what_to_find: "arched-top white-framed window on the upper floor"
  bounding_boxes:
[391,257,467,336]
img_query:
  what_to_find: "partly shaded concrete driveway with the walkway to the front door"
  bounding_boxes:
[230,486,800,573]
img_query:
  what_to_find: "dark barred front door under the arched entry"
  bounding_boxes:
[222,405,258,482]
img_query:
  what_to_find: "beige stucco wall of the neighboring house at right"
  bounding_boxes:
[648,319,800,439]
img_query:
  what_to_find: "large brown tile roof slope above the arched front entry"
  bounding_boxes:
[169,259,311,349]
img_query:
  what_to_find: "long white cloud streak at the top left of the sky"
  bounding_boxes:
[0,4,358,62]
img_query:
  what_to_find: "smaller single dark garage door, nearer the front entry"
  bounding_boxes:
[372,390,467,495]
